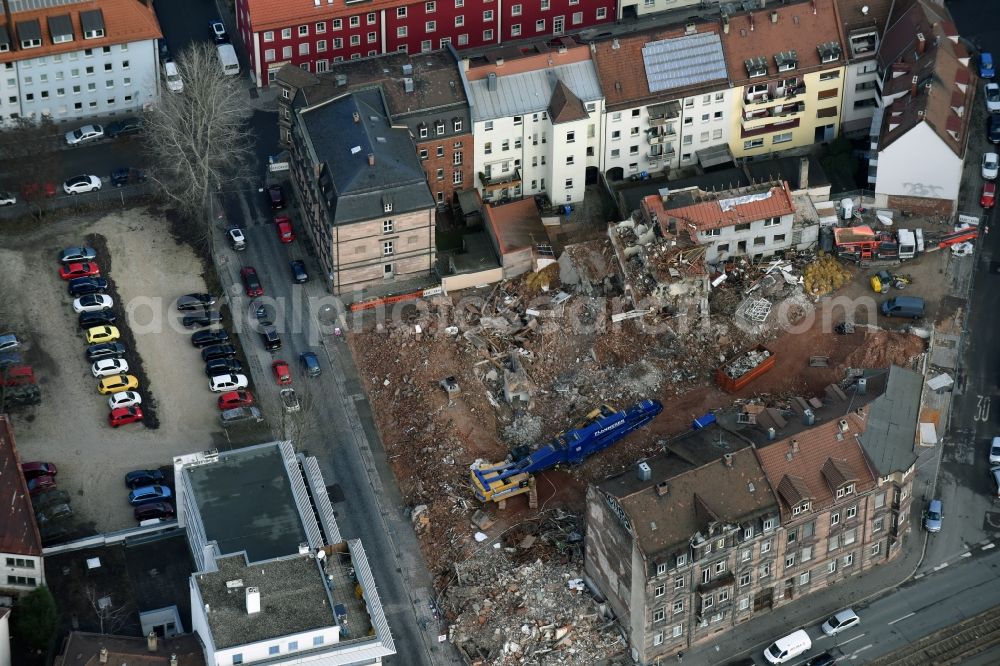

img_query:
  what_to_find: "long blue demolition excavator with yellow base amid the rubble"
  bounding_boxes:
[471,400,663,502]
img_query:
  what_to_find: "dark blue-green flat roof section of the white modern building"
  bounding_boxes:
[186,447,300,562]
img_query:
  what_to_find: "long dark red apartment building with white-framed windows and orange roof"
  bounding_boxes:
[236,0,615,87]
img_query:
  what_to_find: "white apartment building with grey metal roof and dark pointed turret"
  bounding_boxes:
[462,38,604,204]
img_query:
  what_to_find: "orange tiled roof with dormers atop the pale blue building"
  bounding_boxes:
[0,0,163,63]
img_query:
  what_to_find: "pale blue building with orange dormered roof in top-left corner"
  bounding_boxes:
[0,0,161,125]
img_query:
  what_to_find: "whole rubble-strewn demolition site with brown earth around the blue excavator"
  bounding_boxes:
[349,196,967,664]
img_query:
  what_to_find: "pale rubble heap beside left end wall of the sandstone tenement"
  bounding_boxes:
[440,511,623,666]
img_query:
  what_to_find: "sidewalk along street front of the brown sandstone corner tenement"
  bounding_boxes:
[676,510,926,666]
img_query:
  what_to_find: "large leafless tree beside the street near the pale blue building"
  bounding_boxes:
[146,42,253,223]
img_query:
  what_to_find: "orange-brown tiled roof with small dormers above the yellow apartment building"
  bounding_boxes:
[722,0,847,85]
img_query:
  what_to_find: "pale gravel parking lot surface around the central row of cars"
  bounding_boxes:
[0,209,260,532]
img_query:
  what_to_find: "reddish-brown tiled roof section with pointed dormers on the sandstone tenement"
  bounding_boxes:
[757,412,876,518]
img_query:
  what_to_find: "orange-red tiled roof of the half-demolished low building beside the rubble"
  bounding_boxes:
[660,182,795,231]
